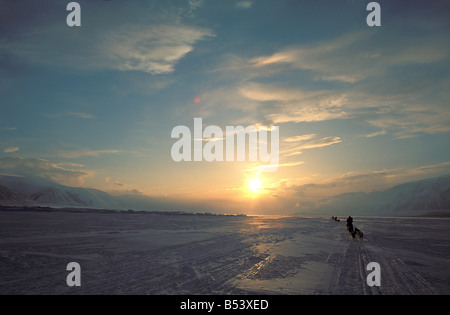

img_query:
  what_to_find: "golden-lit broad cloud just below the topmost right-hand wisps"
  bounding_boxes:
[239,65,450,138]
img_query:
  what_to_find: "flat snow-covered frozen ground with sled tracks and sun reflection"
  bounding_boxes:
[0,211,450,294]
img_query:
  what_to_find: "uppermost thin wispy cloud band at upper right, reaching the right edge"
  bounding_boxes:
[250,32,449,83]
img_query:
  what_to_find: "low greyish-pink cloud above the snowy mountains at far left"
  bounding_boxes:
[0,157,95,185]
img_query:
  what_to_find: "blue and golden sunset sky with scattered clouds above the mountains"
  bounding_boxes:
[0,0,450,214]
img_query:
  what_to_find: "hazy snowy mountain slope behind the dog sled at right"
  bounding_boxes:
[316,175,450,216]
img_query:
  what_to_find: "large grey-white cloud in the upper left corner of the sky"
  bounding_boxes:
[0,0,214,74]
